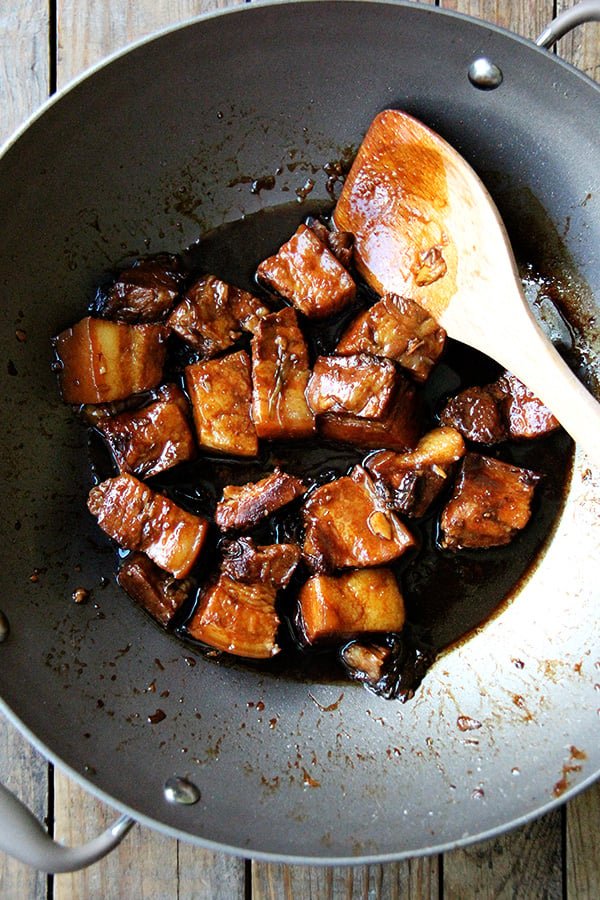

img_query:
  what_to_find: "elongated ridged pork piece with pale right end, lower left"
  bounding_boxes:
[88,474,209,578]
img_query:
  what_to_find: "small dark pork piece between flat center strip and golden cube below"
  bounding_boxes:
[221,537,300,588]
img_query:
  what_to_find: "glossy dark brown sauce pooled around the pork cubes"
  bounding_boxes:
[91,203,572,693]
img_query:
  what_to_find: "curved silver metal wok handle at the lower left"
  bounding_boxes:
[0,784,135,873]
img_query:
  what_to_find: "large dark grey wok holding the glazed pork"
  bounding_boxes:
[0,0,600,863]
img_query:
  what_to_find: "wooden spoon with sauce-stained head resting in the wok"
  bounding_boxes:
[333,110,600,465]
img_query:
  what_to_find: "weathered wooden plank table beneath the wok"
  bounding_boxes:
[0,0,600,900]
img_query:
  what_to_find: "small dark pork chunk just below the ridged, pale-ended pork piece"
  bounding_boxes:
[117,553,193,628]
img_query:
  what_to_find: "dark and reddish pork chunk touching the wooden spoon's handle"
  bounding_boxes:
[440,372,559,444]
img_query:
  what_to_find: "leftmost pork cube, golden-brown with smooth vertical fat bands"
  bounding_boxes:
[53,316,168,403]
